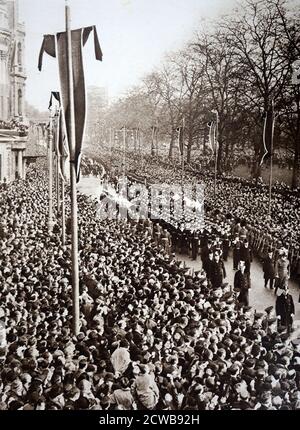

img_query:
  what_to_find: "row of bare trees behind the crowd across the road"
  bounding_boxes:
[86,0,300,187]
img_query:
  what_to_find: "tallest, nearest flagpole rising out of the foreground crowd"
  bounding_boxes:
[65,1,80,336]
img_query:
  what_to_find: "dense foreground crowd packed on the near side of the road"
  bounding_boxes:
[0,161,300,410]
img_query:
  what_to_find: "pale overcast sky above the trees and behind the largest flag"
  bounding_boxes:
[19,0,235,110]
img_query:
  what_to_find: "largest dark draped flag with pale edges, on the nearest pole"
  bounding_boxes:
[38,26,102,181]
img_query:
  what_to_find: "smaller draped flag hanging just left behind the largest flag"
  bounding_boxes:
[49,91,69,181]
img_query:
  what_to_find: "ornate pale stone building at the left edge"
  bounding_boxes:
[0,0,27,182]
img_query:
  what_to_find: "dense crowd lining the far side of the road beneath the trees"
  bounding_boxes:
[89,153,300,276]
